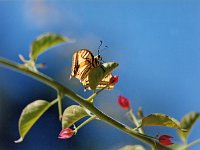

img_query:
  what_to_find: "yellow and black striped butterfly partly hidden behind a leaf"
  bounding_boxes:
[70,49,114,89]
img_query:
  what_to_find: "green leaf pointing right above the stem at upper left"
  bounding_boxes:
[29,33,69,61]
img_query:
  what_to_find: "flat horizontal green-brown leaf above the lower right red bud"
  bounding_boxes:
[142,113,181,129]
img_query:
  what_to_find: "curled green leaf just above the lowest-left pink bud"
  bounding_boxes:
[62,105,88,129]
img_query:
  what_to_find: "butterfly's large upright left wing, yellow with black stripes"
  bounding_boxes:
[70,49,96,82]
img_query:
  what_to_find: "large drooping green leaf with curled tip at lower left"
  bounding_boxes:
[15,100,51,143]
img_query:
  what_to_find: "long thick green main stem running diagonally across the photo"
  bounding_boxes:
[0,57,169,150]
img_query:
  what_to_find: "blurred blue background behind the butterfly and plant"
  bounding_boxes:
[0,0,200,150]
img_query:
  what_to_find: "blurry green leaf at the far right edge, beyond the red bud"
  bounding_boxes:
[177,112,200,142]
